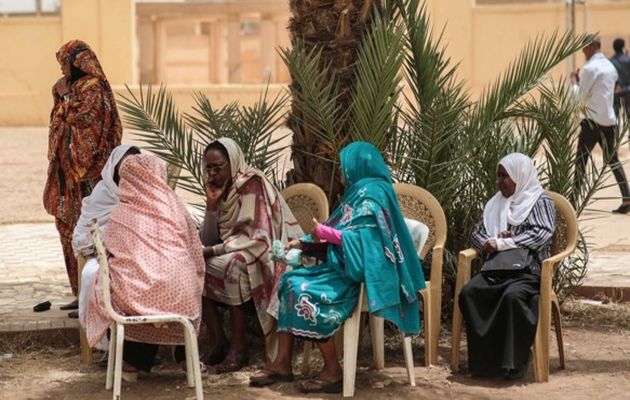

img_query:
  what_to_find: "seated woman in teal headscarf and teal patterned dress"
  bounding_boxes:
[250,142,425,393]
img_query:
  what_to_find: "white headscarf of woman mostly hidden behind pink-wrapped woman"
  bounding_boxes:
[72,144,132,253]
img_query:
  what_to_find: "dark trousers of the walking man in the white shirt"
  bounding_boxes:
[575,119,630,200]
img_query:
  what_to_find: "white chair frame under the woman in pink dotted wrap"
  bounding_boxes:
[91,220,203,400]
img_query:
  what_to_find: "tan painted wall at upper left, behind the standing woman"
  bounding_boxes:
[0,0,135,126]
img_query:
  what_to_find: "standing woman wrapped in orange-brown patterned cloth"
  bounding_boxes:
[44,40,122,309]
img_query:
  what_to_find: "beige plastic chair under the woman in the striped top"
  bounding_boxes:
[451,192,578,382]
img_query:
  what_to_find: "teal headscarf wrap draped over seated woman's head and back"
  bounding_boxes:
[326,142,426,334]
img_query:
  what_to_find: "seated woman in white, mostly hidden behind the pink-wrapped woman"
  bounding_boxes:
[68,145,140,327]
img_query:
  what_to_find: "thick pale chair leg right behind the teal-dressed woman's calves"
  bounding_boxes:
[343,285,364,397]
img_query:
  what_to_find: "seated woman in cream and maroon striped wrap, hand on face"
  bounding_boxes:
[200,138,302,373]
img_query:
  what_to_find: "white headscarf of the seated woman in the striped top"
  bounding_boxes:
[483,153,545,238]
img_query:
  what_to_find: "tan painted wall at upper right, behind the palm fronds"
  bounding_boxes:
[429,0,630,94]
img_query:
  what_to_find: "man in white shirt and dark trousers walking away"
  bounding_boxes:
[571,38,630,214]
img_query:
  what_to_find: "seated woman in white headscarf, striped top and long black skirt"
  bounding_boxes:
[459,153,556,379]
